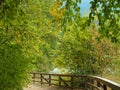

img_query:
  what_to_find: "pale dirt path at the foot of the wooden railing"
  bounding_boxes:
[24,85,80,90]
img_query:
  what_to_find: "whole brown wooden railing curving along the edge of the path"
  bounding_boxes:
[31,72,120,90]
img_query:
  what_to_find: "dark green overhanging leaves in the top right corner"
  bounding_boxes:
[90,0,120,25]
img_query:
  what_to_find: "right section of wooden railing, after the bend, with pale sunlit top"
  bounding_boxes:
[87,76,120,90]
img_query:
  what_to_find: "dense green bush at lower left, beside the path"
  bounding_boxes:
[0,44,29,90]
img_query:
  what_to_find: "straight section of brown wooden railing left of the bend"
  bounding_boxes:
[31,72,87,89]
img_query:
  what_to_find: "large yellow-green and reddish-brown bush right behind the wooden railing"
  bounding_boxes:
[55,21,116,74]
